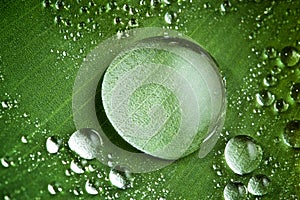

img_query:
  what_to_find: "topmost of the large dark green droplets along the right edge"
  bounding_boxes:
[280,46,300,67]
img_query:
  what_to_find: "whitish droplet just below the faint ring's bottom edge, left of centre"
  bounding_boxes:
[109,166,132,189]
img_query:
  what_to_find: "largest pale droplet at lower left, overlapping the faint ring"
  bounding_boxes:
[68,128,103,160]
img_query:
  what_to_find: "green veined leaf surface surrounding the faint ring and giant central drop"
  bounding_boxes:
[0,0,300,200]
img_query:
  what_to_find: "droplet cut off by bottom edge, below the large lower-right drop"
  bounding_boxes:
[223,182,248,200]
